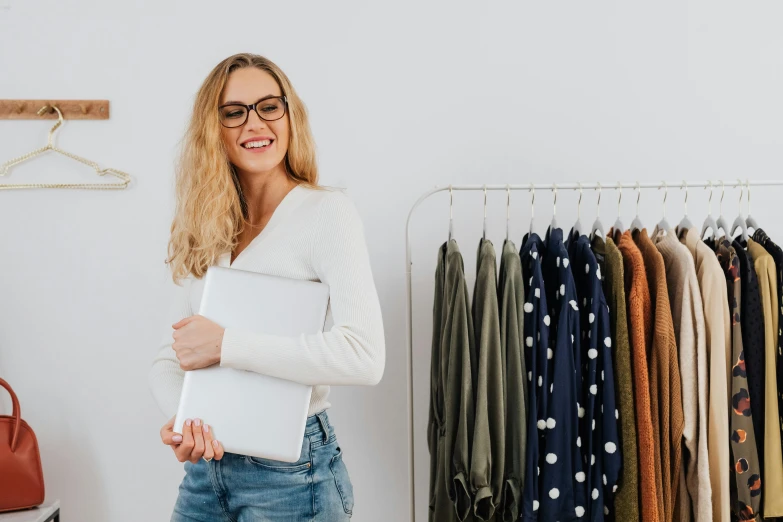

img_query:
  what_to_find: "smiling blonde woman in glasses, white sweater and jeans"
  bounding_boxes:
[150,54,385,522]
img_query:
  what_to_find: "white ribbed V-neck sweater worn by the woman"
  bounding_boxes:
[149,185,385,417]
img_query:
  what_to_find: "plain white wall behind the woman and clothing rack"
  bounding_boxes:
[0,0,783,522]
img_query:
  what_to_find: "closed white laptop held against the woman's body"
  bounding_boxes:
[174,266,329,462]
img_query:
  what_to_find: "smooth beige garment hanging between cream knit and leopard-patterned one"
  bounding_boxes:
[679,228,731,522]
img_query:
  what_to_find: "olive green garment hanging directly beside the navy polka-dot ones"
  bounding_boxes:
[498,240,527,521]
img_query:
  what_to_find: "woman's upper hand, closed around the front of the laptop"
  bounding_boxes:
[171,315,225,370]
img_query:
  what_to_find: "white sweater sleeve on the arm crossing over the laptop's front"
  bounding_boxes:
[220,192,385,385]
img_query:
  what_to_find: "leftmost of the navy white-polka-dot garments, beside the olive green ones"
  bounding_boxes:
[519,234,551,521]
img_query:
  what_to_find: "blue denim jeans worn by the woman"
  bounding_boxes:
[171,411,353,522]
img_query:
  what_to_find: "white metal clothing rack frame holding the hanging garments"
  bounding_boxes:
[405,180,783,522]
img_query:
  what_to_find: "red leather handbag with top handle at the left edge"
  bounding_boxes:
[0,379,45,513]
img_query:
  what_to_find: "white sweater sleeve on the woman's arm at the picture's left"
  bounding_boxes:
[148,279,193,418]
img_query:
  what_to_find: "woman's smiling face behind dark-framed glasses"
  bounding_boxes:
[219,67,290,176]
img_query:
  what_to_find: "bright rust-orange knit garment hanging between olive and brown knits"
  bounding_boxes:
[610,231,664,522]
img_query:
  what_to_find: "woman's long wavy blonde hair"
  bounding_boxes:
[166,53,318,284]
